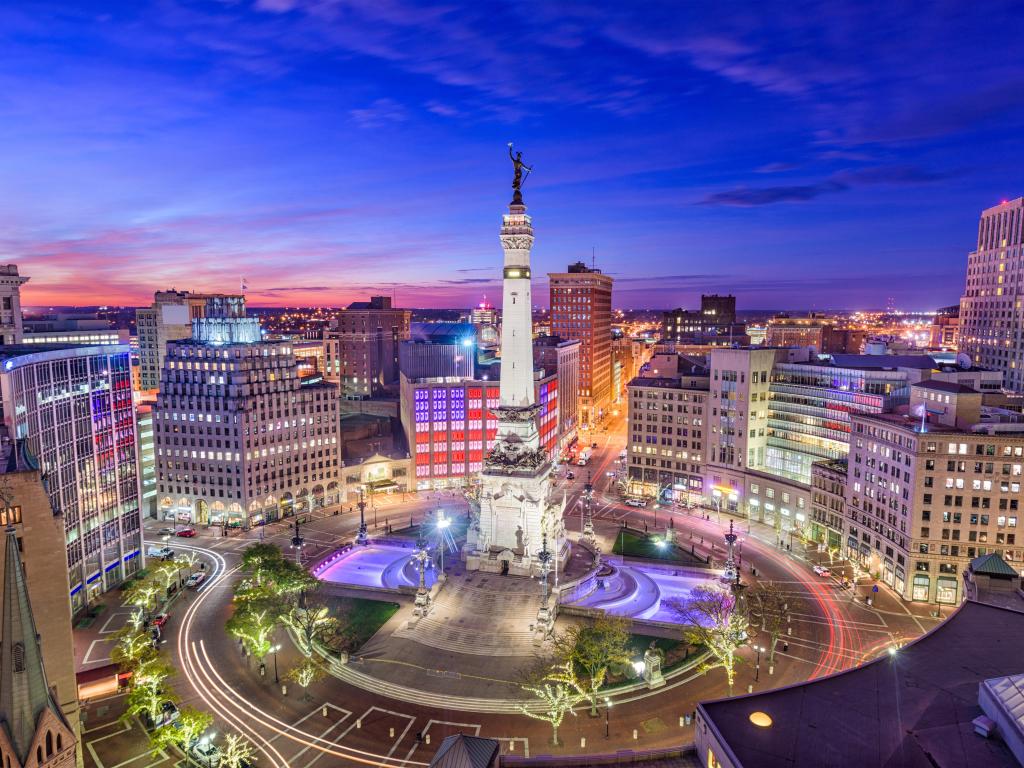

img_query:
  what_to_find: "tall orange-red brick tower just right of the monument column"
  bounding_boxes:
[548,261,612,425]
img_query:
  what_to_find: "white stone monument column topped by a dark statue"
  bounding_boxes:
[466,144,567,575]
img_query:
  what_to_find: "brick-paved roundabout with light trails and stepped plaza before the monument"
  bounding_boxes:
[151,489,937,766]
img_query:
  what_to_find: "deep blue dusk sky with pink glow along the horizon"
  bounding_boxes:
[0,0,1024,309]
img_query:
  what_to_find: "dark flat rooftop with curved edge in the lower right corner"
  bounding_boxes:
[698,602,1024,768]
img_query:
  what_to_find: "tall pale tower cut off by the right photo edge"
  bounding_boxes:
[959,198,1024,392]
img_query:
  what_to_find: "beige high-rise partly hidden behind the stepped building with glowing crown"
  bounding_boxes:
[135,291,245,389]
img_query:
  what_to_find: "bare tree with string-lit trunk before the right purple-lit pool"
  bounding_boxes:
[667,585,748,696]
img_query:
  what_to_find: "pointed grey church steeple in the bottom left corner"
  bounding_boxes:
[0,525,75,766]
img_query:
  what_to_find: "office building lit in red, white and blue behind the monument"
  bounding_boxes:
[401,370,559,490]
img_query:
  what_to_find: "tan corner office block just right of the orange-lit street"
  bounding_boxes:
[627,355,711,506]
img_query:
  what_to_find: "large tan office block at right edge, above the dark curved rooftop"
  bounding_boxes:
[844,380,1024,604]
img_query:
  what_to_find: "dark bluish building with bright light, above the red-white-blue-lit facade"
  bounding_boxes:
[398,323,476,379]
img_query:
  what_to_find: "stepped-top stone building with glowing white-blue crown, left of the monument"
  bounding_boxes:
[153,311,343,528]
